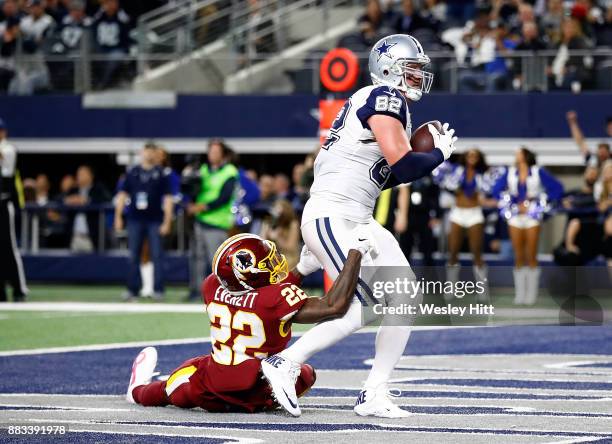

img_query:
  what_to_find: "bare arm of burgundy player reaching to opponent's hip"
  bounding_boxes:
[291,250,361,324]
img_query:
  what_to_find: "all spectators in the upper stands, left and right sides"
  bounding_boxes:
[0,0,612,94]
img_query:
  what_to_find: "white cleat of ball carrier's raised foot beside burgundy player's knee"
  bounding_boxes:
[261,355,302,416]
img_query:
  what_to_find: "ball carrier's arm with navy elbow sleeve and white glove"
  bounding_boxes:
[368,114,455,183]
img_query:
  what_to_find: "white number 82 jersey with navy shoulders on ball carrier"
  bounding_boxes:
[302,85,411,226]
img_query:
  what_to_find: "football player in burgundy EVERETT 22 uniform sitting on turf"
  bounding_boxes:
[126,234,369,412]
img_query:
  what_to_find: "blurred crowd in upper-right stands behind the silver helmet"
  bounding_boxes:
[338,0,612,92]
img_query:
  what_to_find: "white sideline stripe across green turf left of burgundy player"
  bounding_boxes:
[0,302,204,313]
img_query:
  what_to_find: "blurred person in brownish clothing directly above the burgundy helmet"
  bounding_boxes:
[259,199,300,269]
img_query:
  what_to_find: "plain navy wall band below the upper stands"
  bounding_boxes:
[0,92,612,140]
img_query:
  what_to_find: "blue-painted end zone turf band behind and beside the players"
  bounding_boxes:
[0,326,612,399]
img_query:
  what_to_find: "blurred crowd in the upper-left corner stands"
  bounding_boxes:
[0,0,166,95]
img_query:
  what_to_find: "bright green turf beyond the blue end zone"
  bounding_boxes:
[0,285,611,351]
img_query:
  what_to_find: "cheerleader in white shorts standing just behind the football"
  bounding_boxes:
[440,148,488,297]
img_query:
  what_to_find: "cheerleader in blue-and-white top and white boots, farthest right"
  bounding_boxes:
[491,147,563,305]
